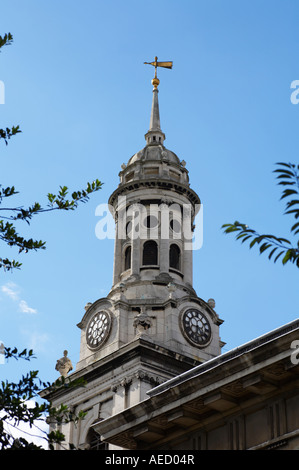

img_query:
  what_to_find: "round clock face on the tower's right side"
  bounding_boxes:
[182,308,211,346]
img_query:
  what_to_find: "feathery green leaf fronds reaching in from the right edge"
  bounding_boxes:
[222,162,299,268]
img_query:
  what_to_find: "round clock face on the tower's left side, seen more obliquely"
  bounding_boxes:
[86,311,111,349]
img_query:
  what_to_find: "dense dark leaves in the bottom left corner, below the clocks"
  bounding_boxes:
[0,348,86,450]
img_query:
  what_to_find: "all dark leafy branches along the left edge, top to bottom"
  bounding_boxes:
[0,29,96,450]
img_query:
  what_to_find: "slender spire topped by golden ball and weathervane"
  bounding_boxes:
[144,57,172,145]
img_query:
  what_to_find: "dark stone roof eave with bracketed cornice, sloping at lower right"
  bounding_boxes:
[93,319,299,449]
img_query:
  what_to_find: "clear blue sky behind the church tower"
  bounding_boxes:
[0,0,299,381]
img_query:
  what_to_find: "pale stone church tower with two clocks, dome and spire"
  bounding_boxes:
[43,58,222,449]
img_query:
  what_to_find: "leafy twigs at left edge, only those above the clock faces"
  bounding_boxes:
[0,33,102,271]
